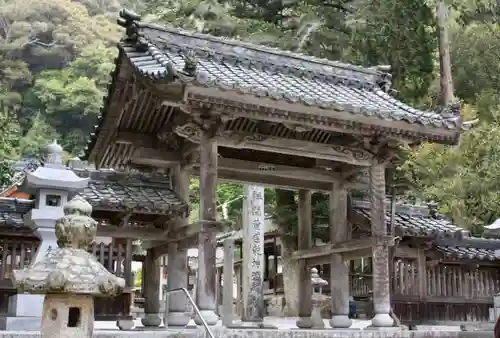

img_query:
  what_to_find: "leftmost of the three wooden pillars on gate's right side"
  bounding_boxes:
[297,190,312,328]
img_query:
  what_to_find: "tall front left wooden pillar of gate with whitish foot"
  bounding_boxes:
[195,129,219,325]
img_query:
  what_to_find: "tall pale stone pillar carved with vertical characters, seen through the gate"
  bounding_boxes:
[242,185,264,323]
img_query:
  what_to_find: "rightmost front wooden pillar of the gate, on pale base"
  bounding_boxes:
[370,163,394,327]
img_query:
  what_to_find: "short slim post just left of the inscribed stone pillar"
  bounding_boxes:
[222,238,234,326]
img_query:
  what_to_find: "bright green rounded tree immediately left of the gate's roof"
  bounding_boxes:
[26,44,114,154]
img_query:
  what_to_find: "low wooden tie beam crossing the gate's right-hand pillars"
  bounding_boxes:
[291,237,395,259]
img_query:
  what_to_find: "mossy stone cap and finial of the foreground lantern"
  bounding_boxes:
[12,196,125,297]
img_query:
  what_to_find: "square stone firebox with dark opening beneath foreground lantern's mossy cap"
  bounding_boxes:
[41,293,94,338]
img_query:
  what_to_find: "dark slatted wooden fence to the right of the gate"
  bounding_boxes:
[351,259,500,322]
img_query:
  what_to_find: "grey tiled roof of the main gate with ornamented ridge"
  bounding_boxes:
[114,7,461,129]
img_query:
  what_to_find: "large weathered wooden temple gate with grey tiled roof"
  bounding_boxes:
[78,10,467,328]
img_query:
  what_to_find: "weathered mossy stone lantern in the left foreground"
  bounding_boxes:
[13,196,125,338]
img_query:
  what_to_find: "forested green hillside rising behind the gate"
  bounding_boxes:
[0,0,500,229]
